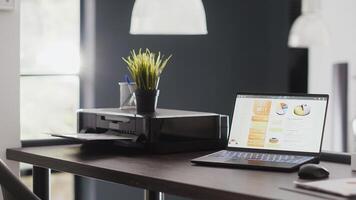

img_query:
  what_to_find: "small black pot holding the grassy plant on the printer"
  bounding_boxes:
[135,89,159,114]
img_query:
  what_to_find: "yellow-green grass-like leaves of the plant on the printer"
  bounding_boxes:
[122,49,172,91]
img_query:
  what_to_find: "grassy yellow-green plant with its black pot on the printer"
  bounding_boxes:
[122,49,172,114]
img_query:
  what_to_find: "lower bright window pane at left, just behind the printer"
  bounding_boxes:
[20,75,79,140]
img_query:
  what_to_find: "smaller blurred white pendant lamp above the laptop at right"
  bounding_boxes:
[288,0,329,48]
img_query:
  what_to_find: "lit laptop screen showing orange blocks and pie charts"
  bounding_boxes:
[228,95,327,153]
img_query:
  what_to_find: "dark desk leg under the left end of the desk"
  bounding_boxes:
[33,166,51,200]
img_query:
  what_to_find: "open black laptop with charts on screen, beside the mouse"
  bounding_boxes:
[191,94,329,171]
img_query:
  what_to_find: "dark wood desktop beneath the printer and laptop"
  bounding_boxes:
[7,145,356,200]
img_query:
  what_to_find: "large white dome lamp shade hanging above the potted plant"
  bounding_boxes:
[130,0,208,35]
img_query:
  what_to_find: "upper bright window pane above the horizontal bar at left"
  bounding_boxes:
[20,0,80,74]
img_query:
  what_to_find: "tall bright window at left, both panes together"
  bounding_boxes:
[20,0,80,140]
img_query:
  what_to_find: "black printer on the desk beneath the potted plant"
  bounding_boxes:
[78,108,229,153]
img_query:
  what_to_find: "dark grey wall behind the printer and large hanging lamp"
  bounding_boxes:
[81,0,306,200]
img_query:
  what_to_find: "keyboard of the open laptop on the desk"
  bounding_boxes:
[211,150,312,164]
